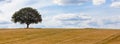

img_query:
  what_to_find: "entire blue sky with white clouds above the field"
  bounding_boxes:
[0,0,120,28]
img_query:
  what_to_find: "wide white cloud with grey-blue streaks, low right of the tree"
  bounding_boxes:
[42,14,91,28]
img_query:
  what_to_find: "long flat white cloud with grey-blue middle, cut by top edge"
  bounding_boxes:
[53,0,89,5]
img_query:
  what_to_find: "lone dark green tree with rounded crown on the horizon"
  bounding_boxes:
[12,7,42,28]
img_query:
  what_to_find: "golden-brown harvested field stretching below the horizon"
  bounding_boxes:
[0,28,120,44]
